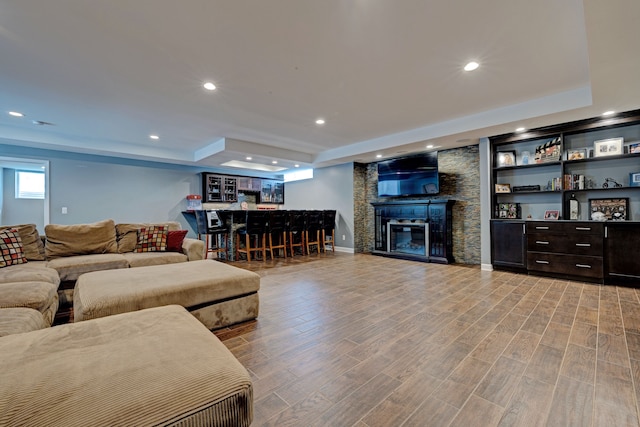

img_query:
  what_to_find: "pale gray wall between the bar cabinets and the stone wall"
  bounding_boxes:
[282,163,354,249]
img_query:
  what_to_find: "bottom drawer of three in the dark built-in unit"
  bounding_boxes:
[527,252,603,279]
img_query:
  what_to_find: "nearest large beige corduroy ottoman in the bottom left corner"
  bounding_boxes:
[0,305,253,427]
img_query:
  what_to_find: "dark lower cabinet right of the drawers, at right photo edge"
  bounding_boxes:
[604,221,640,287]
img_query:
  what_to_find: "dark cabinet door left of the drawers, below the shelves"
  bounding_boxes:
[491,220,527,270]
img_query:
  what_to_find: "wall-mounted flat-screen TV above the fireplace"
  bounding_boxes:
[378,151,440,197]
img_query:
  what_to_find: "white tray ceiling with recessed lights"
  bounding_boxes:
[0,0,640,176]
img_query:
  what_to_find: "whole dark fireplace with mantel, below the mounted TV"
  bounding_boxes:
[371,199,454,264]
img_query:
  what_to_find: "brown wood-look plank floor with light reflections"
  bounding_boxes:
[215,253,640,427]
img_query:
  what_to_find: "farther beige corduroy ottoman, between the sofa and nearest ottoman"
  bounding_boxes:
[73,260,260,329]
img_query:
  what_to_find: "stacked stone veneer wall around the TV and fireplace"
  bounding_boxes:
[353,145,480,264]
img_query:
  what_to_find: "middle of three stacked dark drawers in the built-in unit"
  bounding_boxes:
[527,233,603,256]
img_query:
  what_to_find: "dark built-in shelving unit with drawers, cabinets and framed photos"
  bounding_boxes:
[489,110,640,287]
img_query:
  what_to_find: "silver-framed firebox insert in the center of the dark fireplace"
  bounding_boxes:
[387,220,429,257]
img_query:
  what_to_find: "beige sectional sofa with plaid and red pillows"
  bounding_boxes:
[0,219,205,336]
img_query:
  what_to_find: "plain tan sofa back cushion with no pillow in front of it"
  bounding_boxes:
[44,219,118,260]
